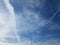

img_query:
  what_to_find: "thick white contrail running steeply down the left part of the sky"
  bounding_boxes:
[4,0,20,42]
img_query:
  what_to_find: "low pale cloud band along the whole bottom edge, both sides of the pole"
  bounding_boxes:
[0,39,60,45]
